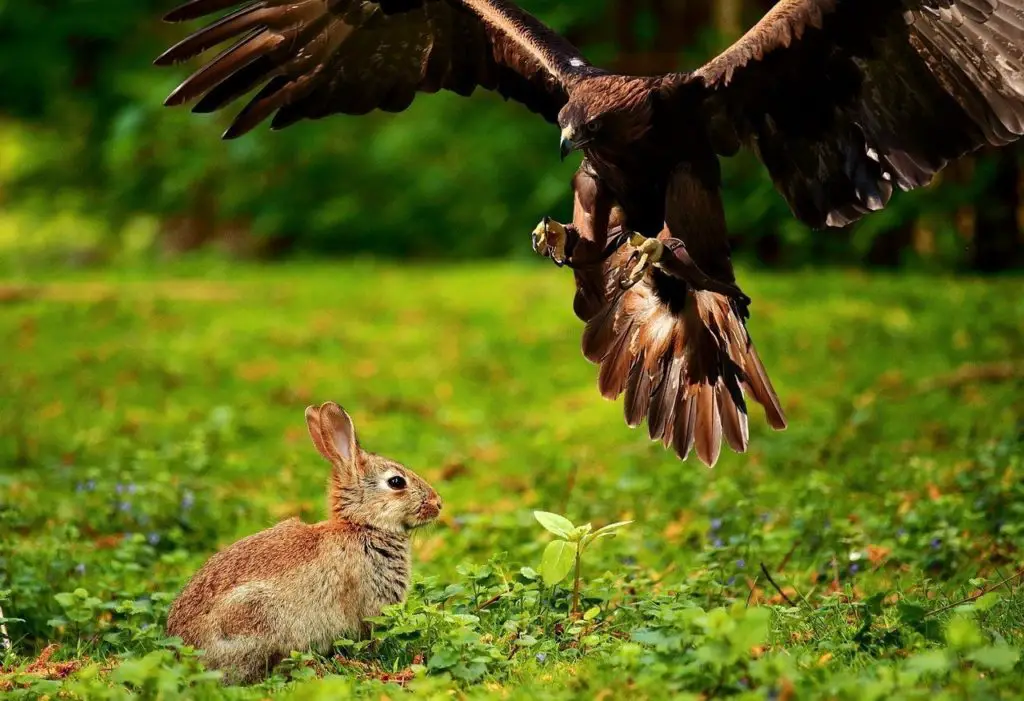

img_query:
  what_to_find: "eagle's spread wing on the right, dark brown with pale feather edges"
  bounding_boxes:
[666,0,1024,227]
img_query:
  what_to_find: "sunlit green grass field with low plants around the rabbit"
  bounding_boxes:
[0,262,1024,700]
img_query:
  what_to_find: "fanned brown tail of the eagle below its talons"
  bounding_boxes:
[583,259,785,467]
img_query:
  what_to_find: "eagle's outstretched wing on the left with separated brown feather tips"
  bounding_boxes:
[156,0,598,138]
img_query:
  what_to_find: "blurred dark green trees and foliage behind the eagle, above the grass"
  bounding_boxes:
[0,0,1024,271]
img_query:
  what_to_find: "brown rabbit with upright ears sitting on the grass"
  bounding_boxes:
[167,402,441,684]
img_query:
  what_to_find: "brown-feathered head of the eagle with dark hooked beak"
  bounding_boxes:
[558,76,651,161]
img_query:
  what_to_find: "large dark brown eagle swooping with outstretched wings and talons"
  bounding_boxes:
[156,0,1024,467]
